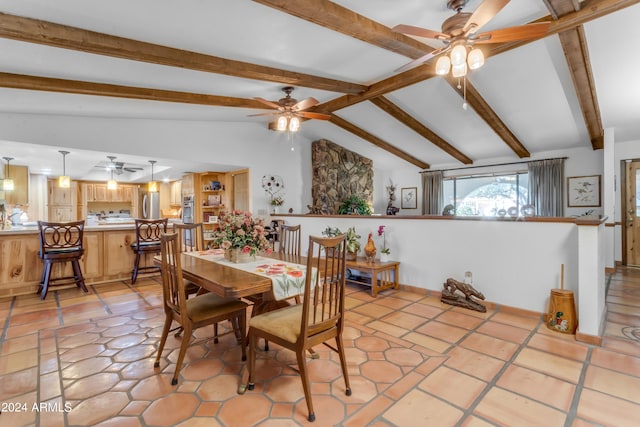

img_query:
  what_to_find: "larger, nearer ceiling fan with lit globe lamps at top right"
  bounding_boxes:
[392,0,550,77]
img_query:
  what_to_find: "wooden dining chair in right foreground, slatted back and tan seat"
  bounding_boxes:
[238,235,351,421]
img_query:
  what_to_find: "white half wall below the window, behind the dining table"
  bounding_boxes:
[285,216,578,313]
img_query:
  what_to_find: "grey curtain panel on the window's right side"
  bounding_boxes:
[529,159,564,217]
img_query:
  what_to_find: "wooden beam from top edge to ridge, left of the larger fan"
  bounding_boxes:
[253,0,435,59]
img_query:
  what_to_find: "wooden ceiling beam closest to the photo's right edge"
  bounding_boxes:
[545,0,604,150]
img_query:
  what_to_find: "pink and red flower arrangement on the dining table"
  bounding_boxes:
[213,211,271,262]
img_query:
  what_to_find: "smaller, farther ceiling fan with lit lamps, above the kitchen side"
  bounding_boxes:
[249,86,331,132]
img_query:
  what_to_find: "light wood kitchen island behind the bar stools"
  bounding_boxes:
[0,221,171,299]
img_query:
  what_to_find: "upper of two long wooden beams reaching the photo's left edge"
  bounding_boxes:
[0,13,367,93]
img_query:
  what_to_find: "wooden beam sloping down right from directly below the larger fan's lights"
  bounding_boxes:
[445,75,531,158]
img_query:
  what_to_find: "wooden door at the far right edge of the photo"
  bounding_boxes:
[620,159,640,267]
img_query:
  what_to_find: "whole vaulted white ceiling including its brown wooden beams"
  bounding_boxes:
[0,0,640,179]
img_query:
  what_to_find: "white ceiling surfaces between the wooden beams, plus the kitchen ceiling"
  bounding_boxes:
[0,0,640,181]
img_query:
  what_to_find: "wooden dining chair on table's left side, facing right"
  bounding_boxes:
[153,233,247,385]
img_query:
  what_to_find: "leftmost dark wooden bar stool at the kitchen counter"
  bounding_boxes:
[38,221,89,300]
